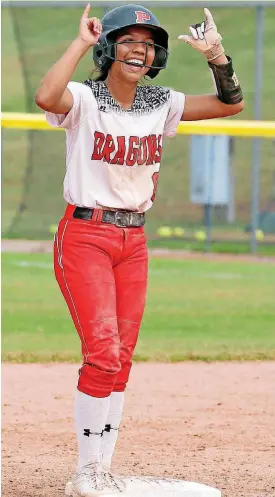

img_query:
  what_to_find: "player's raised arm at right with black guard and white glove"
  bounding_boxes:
[179,9,244,121]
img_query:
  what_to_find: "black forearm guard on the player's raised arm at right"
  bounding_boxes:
[208,57,243,104]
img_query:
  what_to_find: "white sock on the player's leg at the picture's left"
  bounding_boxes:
[75,390,110,471]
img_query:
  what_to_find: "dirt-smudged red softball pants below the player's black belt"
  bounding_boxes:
[54,205,148,397]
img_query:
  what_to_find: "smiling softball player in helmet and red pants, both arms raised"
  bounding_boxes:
[35,5,243,497]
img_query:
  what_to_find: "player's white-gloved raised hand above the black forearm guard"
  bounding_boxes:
[178,9,224,61]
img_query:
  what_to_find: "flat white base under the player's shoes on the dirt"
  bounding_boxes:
[65,476,221,497]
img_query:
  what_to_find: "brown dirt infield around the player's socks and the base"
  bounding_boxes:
[2,362,275,497]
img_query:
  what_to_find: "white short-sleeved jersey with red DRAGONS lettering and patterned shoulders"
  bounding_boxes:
[46,80,185,212]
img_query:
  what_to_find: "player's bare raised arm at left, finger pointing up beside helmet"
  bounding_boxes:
[35,4,102,114]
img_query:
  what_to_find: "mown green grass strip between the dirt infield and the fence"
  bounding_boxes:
[2,254,275,362]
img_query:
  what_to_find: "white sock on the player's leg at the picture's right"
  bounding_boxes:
[100,392,124,468]
